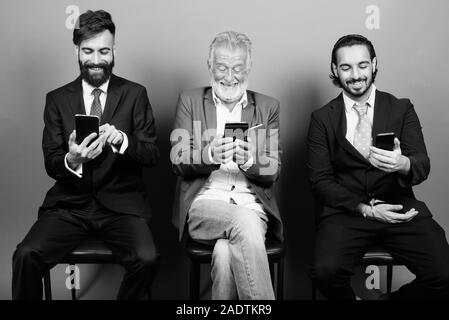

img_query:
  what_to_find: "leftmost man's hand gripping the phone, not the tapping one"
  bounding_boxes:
[67,130,104,169]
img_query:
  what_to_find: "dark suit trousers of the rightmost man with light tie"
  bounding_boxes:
[312,214,449,299]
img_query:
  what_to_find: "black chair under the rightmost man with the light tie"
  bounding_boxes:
[312,247,402,300]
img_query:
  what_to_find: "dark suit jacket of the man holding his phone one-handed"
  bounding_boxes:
[307,91,430,217]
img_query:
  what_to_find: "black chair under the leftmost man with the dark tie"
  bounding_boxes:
[44,237,158,300]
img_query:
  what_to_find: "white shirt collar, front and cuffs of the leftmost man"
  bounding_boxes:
[64,80,128,178]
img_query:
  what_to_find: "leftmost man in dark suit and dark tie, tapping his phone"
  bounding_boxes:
[12,10,159,299]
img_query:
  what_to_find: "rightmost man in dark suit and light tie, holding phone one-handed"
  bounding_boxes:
[307,35,449,299]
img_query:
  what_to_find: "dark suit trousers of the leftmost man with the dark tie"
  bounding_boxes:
[12,200,157,299]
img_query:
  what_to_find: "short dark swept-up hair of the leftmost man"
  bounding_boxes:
[73,10,115,46]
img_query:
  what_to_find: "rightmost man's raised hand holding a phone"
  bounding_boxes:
[368,138,410,175]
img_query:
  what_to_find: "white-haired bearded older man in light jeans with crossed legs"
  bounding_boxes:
[171,31,282,300]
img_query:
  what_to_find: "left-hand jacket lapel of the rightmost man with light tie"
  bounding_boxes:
[329,93,369,163]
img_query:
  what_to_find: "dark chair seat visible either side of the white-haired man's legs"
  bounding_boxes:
[186,239,285,263]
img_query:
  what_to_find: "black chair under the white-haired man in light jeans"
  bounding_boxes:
[186,238,285,300]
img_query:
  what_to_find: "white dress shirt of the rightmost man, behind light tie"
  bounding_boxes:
[343,84,376,145]
